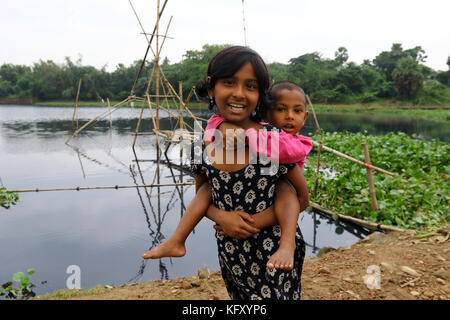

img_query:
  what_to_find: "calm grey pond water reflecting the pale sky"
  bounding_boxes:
[0,106,446,294]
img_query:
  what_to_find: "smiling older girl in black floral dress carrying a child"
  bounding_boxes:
[144,46,307,299]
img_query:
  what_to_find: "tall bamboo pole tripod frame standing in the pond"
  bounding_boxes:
[66,0,205,190]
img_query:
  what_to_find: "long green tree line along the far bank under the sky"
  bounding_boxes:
[0,43,450,105]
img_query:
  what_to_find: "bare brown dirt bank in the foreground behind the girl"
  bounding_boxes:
[37,225,450,300]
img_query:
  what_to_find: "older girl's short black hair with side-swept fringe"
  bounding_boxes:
[195,46,269,121]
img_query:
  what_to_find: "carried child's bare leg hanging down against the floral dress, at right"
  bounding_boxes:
[267,179,300,270]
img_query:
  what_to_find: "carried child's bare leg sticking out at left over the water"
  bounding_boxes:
[142,183,211,259]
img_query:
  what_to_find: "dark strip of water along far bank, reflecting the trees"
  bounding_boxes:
[0,107,450,142]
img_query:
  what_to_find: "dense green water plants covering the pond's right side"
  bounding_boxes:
[305,132,450,229]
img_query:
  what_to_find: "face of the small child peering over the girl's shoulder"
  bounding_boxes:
[269,89,308,135]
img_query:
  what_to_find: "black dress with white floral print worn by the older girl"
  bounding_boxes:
[191,125,305,300]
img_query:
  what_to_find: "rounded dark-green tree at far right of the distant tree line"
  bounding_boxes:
[392,57,423,98]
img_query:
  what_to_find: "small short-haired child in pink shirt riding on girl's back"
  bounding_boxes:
[206,81,312,270]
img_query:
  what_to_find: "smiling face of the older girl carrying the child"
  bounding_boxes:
[208,62,259,128]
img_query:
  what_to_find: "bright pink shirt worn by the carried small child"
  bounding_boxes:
[205,113,312,169]
